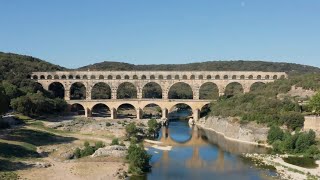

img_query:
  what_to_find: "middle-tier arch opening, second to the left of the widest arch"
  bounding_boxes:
[117,82,138,99]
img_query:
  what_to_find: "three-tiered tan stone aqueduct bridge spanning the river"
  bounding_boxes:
[31,71,287,120]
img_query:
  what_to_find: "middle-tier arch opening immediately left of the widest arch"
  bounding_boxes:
[142,82,162,99]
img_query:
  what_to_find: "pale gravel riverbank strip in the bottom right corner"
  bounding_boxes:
[243,153,320,180]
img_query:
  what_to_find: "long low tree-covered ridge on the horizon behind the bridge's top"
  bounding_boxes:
[79,60,320,74]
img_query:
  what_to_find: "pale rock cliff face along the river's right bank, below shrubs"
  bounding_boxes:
[197,116,269,143]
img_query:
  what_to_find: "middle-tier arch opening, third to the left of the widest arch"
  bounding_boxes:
[91,82,111,99]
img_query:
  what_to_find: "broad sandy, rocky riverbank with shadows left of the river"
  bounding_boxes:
[0,117,155,180]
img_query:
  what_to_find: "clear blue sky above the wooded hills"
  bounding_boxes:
[0,0,320,68]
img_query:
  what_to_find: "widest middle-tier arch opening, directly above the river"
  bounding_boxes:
[168,82,193,99]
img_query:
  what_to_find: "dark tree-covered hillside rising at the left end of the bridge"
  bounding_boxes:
[0,52,66,85]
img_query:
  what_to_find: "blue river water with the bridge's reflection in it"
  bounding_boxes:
[144,119,273,179]
